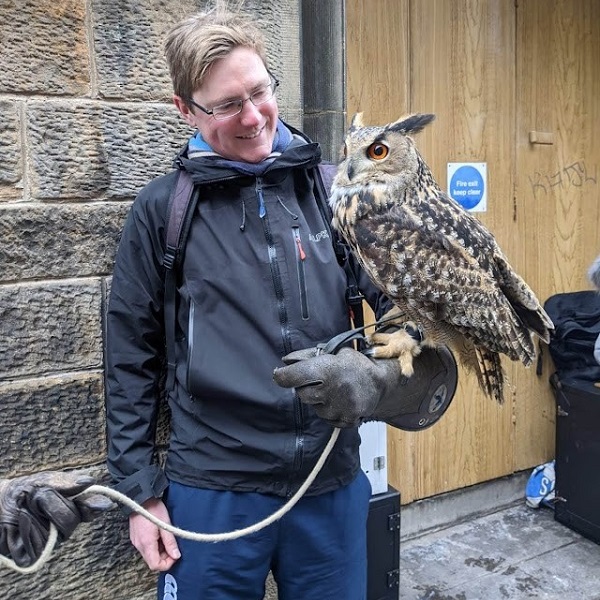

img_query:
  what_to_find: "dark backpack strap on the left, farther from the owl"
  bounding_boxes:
[163,171,199,391]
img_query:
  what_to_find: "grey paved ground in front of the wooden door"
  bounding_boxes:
[400,474,600,600]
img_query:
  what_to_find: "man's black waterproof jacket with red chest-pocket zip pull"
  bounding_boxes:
[106,127,390,502]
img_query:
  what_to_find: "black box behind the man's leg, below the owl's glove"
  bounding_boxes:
[367,486,400,600]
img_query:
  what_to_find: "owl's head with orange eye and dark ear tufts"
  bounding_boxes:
[335,113,435,186]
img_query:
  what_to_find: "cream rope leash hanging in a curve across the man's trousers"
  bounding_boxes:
[0,427,340,575]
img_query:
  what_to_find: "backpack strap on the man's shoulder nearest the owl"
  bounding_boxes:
[314,163,365,327]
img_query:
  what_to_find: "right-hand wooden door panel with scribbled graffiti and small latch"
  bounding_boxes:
[513,0,600,470]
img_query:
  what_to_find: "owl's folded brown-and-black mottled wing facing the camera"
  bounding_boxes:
[353,193,537,364]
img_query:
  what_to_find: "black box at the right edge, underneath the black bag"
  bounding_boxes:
[551,376,600,544]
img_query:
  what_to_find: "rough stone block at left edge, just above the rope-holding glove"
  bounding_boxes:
[0,371,106,476]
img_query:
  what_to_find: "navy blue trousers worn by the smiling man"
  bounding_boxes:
[158,471,371,600]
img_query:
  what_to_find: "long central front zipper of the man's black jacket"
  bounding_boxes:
[256,177,304,496]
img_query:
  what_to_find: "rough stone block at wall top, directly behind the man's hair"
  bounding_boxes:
[92,0,301,109]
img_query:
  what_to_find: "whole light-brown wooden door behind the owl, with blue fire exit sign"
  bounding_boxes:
[346,0,600,503]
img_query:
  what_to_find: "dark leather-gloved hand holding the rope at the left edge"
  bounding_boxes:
[0,471,113,567]
